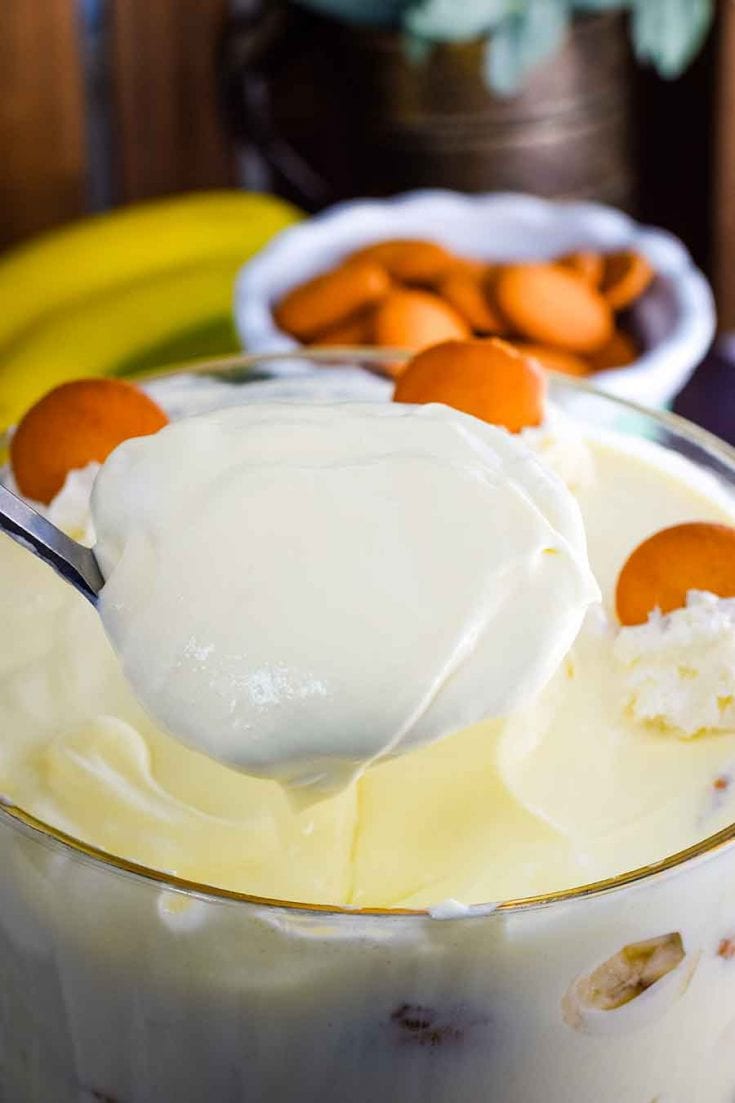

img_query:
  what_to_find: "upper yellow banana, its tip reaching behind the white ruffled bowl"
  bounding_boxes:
[0,190,299,357]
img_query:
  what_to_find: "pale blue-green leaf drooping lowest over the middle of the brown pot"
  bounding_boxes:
[486,0,571,96]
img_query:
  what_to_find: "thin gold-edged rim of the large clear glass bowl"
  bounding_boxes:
[0,347,735,921]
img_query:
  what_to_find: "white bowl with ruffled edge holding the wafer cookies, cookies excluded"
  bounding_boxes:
[235,190,715,406]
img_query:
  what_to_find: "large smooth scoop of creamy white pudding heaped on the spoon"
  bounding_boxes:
[92,404,598,792]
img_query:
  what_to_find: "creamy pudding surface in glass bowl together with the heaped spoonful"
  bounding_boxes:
[0,346,735,908]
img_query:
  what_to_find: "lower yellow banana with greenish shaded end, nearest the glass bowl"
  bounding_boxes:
[0,254,242,427]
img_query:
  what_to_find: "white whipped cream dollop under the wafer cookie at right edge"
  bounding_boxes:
[614,590,735,737]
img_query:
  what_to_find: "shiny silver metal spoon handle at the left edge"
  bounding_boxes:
[0,483,105,606]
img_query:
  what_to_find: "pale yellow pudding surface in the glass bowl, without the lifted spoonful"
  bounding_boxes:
[0,375,735,907]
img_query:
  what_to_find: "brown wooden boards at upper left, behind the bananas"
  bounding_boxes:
[0,0,234,247]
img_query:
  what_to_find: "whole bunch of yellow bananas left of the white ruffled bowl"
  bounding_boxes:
[0,191,299,427]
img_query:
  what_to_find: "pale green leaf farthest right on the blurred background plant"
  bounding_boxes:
[632,0,714,79]
